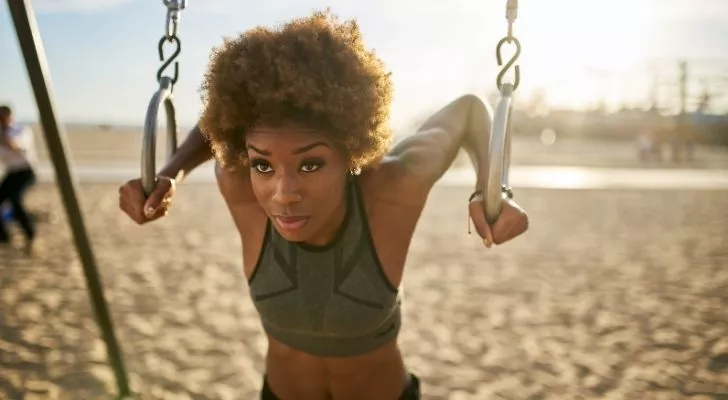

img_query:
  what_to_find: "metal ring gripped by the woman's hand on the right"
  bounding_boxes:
[485,83,513,224]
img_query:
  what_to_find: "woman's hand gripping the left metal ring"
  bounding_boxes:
[119,176,176,225]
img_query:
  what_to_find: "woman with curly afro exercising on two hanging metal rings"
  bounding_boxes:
[120,12,528,400]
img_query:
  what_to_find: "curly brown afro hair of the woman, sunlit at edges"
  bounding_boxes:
[200,9,392,170]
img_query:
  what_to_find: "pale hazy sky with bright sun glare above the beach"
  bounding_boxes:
[0,0,728,129]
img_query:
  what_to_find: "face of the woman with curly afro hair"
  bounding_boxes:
[246,127,348,245]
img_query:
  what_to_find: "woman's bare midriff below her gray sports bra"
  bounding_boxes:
[266,336,408,400]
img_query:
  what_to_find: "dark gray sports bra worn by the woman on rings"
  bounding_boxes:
[248,177,401,357]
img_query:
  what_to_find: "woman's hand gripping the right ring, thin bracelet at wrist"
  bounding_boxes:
[468,194,528,248]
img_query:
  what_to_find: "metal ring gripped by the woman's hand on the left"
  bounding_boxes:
[142,76,177,196]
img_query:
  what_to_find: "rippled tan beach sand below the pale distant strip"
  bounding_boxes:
[0,185,728,400]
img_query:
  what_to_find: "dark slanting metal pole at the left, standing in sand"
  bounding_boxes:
[7,0,131,398]
